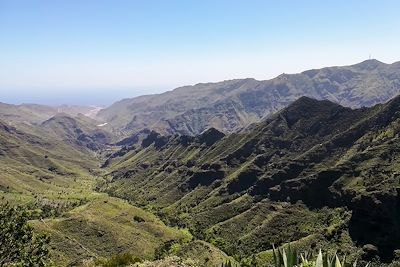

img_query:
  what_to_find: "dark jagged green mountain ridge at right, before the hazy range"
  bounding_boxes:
[102,95,400,266]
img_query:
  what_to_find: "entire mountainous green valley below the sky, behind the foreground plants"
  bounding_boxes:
[0,60,400,266]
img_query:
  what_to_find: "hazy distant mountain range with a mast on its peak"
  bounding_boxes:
[98,60,400,137]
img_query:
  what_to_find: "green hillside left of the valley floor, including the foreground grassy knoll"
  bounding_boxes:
[0,115,229,266]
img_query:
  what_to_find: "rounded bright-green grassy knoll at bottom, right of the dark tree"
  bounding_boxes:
[34,195,191,265]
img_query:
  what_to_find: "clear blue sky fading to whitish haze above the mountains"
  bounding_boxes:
[0,0,400,105]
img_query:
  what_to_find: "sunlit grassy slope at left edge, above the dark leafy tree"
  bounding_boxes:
[0,119,97,205]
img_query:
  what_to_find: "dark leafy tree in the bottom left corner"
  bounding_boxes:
[0,204,49,267]
